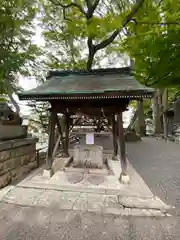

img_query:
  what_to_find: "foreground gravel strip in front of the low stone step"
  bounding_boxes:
[0,204,180,240]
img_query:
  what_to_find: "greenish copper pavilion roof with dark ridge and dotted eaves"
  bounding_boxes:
[18,68,154,100]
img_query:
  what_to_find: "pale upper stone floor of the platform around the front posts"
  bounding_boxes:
[18,161,153,198]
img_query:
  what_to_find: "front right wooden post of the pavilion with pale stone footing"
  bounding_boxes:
[118,110,130,184]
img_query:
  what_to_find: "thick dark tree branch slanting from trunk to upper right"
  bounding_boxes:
[95,0,145,51]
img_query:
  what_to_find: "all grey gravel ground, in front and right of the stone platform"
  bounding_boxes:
[0,135,180,240]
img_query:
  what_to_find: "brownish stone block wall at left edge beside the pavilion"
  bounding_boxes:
[0,138,37,188]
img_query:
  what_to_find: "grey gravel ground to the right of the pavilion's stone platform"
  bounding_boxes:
[127,137,180,216]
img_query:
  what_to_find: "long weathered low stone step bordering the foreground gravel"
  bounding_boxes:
[1,187,170,216]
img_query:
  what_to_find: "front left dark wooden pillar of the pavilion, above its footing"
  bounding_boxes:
[46,108,56,170]
